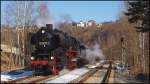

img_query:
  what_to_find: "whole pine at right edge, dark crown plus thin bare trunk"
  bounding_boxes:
[125,0,149,73]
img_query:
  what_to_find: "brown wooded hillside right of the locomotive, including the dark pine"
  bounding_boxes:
[61,0,150,76]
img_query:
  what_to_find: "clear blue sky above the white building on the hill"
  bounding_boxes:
[1,1,123,23]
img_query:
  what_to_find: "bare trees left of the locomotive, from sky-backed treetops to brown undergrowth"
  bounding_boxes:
[1,1,46,68]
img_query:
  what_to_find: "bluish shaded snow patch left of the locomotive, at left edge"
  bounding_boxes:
[1,70,32,81]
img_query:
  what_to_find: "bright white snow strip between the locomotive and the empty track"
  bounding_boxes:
[47,68,90,83]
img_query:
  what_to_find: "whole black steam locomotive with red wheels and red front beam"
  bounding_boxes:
[30,24,86,75]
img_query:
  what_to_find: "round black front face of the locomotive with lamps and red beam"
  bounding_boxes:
[31,24,60,74]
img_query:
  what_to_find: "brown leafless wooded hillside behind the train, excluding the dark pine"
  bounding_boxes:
[60,16,149,75]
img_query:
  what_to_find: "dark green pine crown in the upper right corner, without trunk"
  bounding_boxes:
[125,0,149,32]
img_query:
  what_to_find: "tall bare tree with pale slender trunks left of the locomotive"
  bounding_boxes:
[3,1,34,66]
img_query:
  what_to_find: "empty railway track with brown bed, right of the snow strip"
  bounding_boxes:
[70,63,111,83]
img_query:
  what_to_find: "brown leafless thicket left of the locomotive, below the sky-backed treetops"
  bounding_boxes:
[1,26,38,70]
